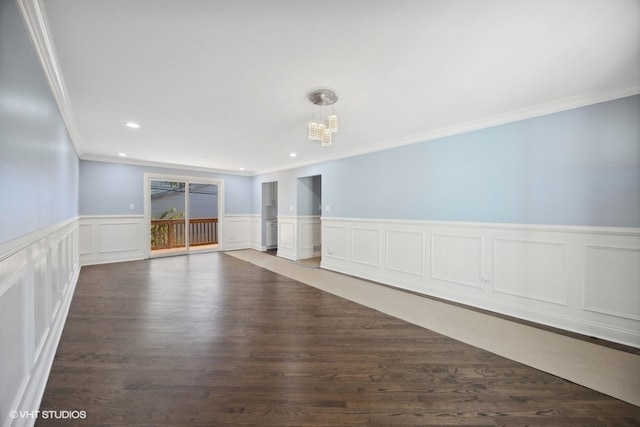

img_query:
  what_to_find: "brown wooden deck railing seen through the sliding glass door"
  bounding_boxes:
[151,218,218,250]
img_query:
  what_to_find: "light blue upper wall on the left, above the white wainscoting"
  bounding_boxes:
[0,0,78,243]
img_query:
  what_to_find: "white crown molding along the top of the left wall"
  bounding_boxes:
[16,0,82,157]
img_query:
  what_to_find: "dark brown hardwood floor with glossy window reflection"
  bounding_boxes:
[36,253,640,426]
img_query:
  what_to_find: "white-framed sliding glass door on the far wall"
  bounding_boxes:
[145,176,222,256]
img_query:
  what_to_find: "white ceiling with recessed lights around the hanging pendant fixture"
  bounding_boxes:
[26,0,640,174]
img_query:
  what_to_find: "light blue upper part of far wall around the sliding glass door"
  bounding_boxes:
[80,160,251,215]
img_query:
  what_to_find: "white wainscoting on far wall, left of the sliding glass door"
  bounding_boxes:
[79,215,150,265]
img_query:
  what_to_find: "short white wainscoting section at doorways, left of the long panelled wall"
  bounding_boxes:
[278,215,322,260]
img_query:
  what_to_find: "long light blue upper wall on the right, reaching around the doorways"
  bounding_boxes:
[252,95,640,231]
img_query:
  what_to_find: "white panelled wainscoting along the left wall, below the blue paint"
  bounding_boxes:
[0,219,80,427]
